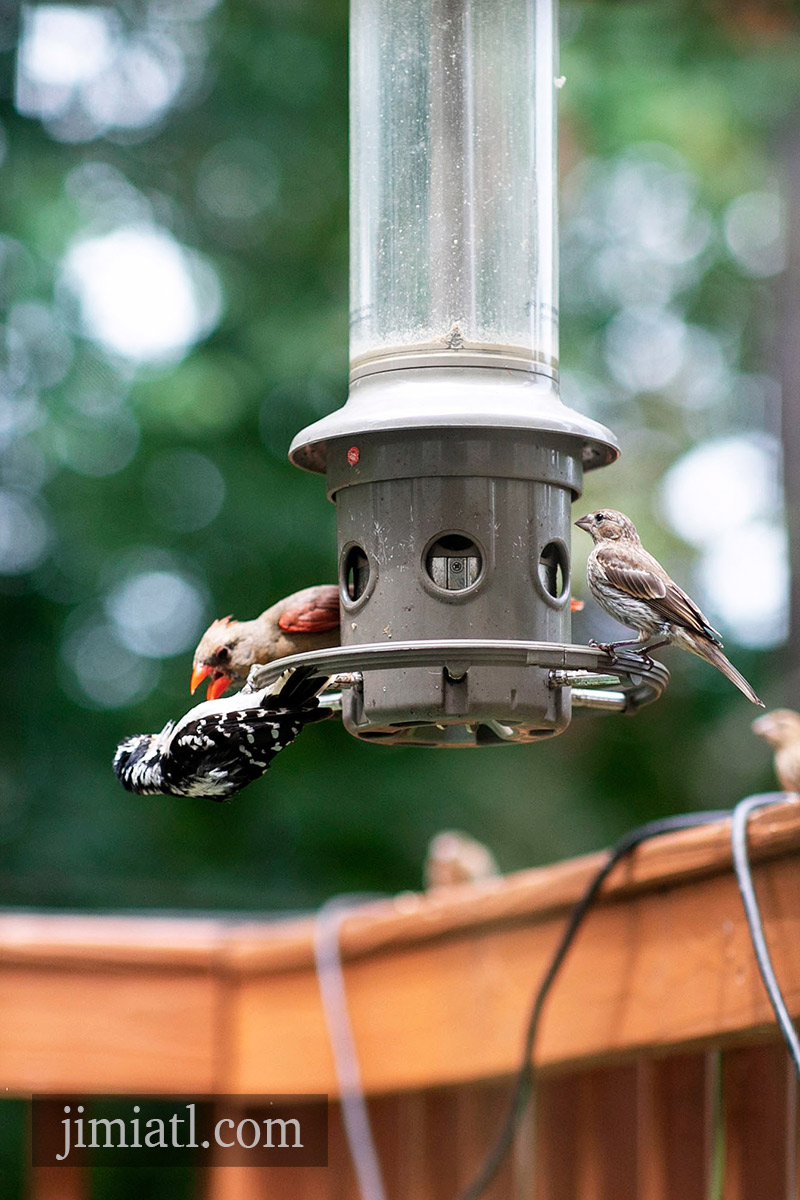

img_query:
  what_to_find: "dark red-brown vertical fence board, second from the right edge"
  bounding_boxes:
[638,1054,715,1200]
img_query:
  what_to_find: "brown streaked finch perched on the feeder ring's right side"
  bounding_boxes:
[576,509,764,708]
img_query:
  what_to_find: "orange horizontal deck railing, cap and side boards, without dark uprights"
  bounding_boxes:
[0,804,800,1096]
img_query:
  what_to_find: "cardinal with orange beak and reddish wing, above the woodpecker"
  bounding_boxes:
[191,584,339,700]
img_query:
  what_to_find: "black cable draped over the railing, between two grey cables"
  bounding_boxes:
[458,809,730,1200]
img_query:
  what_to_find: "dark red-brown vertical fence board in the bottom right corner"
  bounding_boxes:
[722,1044,796,1200]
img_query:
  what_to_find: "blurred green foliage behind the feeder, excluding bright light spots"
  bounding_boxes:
[0,0,800,911]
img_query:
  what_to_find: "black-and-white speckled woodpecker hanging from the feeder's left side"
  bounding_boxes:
[114,667,329,800]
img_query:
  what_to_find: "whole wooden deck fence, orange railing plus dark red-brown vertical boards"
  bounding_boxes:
[0,805,800,1200]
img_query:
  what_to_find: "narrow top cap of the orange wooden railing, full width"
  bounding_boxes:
[0,803,800,976]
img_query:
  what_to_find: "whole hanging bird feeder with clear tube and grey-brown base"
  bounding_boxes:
[289,0,666,745]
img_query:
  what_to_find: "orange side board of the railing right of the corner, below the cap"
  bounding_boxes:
[225,858,800,1094]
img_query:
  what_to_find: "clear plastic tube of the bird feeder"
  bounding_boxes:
[350,0,558,374]
